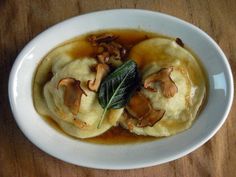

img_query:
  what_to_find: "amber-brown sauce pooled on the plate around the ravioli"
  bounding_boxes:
[40,29,205,144]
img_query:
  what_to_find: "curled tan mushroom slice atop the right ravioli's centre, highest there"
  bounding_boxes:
[144,67,178,98]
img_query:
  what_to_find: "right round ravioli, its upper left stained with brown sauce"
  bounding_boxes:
[120,38,206,137]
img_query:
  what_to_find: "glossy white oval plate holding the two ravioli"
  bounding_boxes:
[9,9,233,169]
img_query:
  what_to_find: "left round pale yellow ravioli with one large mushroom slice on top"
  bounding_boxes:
[34,47,123,138]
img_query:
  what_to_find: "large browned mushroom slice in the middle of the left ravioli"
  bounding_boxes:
[57,77,87,115]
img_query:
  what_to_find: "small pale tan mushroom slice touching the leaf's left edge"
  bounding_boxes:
[87,63,110,92]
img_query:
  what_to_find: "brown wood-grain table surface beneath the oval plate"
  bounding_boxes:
[0,0,236,177]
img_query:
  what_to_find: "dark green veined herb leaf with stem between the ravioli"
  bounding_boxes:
[98,60,139,128]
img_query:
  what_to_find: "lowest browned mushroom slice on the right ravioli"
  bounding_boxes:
[137,109,165,127]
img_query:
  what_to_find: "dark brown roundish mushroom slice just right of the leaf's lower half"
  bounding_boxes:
[126,92,152,120]
